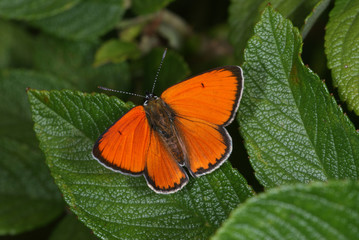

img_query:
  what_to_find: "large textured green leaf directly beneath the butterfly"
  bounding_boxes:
[28,90,252,239]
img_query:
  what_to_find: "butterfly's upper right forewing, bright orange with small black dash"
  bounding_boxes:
[161,66,243,126]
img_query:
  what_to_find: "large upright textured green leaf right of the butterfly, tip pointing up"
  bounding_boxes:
[238,7,359,187]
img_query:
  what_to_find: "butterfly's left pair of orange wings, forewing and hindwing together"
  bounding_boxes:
[92,106,188,193]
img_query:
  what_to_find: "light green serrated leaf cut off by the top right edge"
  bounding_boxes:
[325,0,359,115]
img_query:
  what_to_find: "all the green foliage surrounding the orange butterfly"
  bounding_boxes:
[0,0,359,239]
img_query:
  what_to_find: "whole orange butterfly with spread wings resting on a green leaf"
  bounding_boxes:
[92,61,243,194]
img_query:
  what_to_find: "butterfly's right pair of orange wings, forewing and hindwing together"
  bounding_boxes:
[161,66,243,176]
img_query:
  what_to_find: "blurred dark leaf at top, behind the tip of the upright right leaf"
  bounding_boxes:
[229,0,320,61]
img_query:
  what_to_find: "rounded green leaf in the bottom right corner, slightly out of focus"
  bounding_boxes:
[212,181,359,240]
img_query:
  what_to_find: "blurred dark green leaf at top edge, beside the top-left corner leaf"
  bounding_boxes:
[32,0,125,40]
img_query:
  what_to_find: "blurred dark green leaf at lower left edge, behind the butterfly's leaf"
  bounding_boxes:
[0,136,64,235]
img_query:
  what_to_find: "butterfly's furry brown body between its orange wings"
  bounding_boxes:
[143,95,184,164]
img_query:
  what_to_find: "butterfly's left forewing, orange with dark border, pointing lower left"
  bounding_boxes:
[92,106,150,175]
